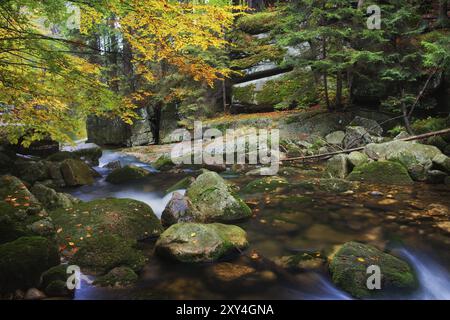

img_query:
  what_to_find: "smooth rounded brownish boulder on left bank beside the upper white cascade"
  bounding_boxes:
[61,159,94,187]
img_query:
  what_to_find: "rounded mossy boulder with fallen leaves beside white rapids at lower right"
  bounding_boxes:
[329,242,417,298]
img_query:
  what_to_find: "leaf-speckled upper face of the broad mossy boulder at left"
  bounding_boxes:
[50,198,163,246]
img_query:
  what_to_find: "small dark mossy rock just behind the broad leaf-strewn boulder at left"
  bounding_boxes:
[31,182,80,210]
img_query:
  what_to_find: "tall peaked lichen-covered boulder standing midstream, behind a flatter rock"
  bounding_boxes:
[186,171,251,222]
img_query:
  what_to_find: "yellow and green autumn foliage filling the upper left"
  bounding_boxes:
[0,0,238,144]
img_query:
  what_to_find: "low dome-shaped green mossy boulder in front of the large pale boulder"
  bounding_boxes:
[347,161,413,185]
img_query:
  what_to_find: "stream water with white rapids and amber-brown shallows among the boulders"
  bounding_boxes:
[70,151,450,300]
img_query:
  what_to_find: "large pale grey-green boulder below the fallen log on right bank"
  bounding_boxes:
[364,140,441,181]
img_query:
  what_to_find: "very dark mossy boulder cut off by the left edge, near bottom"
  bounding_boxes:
[0,237,59,292]
